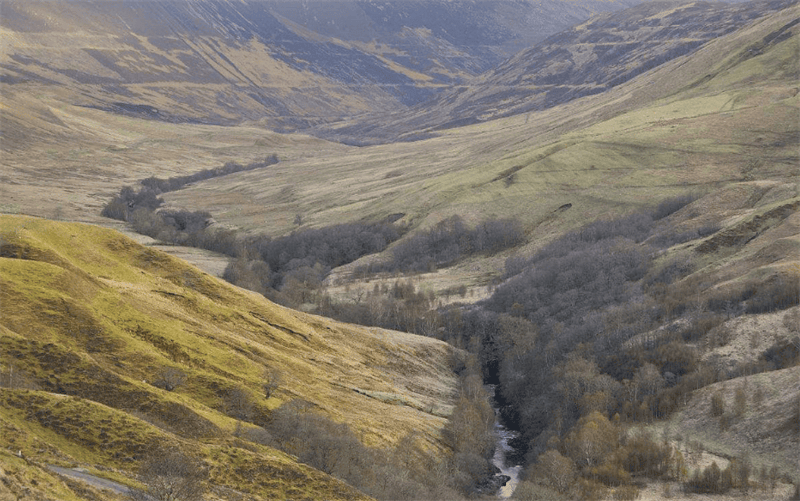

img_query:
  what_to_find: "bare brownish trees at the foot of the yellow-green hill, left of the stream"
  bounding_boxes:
[206,353,495,500]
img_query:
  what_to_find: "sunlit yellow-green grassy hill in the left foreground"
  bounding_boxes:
[0,216,455,499]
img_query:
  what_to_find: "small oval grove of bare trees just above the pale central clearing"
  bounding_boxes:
[356,215,525,274]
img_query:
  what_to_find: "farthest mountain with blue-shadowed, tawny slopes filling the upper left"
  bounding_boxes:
[0,0,638,128]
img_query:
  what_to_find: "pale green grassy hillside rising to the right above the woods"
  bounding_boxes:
[162,6,800,290]
